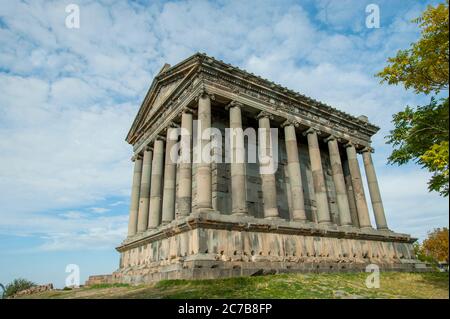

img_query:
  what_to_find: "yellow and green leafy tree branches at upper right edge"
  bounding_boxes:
[377,0,449,196]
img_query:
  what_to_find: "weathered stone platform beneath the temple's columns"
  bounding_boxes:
[110,212,421,284]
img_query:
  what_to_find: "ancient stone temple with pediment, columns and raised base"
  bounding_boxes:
[96,53,421,283]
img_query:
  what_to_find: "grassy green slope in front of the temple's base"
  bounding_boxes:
[16,272,449,299]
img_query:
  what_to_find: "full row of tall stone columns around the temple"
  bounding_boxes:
[128,91,387,236]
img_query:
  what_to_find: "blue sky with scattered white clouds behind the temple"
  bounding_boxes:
[0,0,449,287]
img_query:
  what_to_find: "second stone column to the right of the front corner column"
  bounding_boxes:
[257,112,280,218]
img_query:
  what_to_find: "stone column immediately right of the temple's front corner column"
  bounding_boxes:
[229,101,247,214]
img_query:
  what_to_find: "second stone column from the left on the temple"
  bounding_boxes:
[137,147,153,232]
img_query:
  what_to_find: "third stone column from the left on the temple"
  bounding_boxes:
[148,137,164,228]
